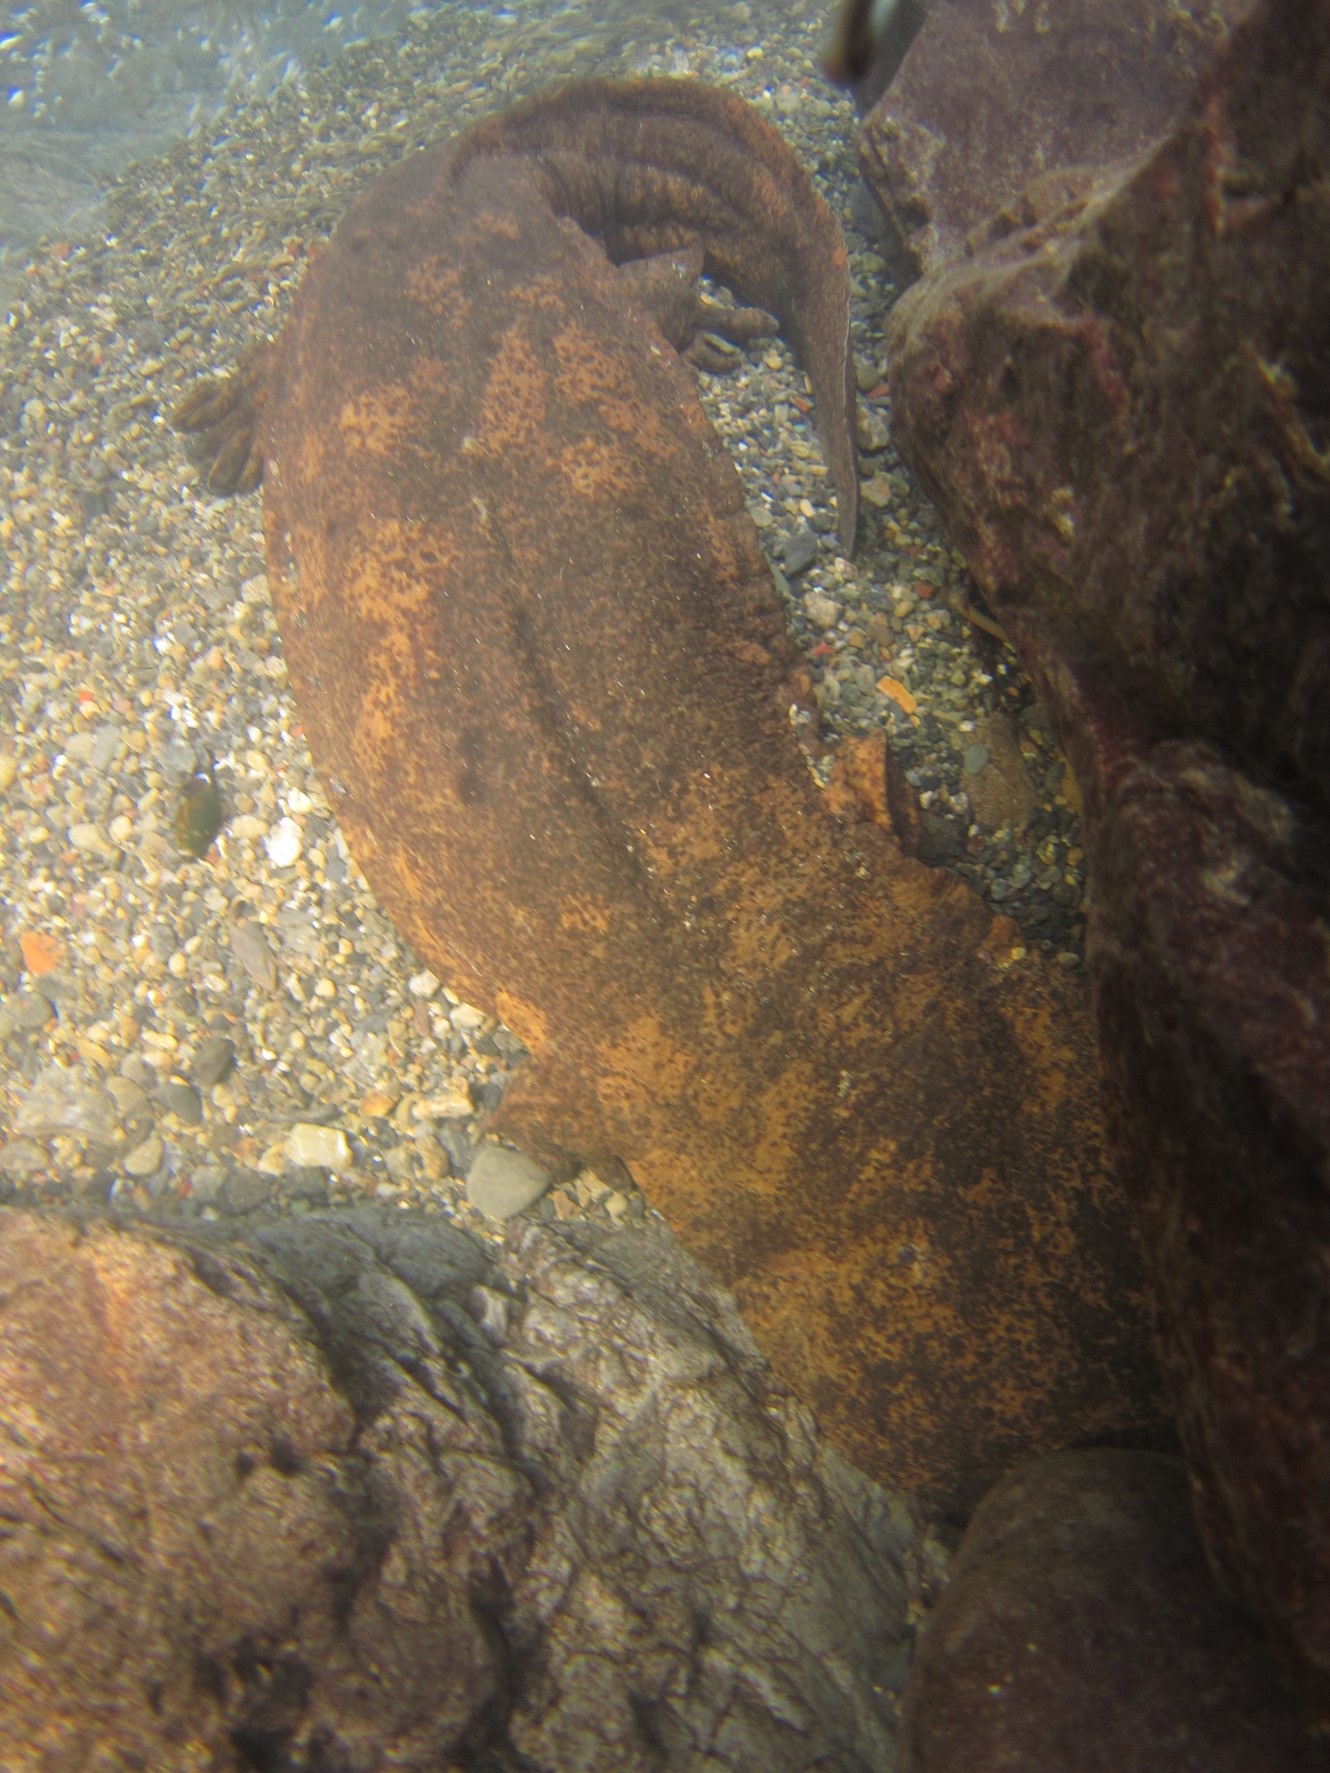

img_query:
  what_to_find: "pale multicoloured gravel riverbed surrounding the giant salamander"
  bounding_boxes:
[0,0,1084,1232]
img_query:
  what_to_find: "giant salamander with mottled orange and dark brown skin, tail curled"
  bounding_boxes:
[179,82,1160,1502]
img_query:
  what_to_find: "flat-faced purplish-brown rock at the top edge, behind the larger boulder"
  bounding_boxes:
[860,0,1252,282]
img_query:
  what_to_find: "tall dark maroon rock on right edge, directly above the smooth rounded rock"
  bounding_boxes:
[1091,741,1330,1718]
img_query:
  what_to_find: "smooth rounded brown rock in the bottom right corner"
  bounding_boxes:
[897,1452,1328,1773]
